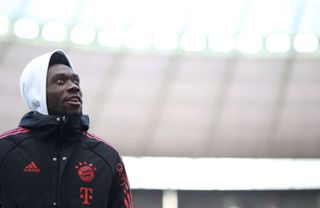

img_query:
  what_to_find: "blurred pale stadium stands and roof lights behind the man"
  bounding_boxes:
[0,0,320,208]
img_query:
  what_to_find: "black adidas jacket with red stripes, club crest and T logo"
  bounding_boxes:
[0,112,133,208]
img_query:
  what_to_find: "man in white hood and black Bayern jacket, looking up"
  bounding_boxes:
[0,50,133,208]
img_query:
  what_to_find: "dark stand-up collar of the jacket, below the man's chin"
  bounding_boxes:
[19,111,89,140]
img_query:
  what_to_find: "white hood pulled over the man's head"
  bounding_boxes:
[20,50,74,115]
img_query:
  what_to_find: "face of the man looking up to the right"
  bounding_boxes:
[47,64,82,115]
